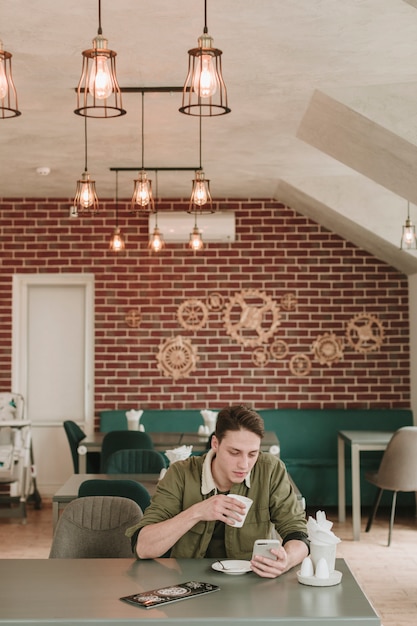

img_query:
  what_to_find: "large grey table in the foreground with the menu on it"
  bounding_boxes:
[0,558,381,626]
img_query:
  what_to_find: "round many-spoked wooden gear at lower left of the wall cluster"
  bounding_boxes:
[157,335,199,381]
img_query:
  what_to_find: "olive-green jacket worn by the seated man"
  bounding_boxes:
[126,452,307,559]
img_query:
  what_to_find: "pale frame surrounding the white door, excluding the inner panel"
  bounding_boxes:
[12,273,95,433]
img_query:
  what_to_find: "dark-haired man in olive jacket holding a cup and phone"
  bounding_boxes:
[128,406,308,578]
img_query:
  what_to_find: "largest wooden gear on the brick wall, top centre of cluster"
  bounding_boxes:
[224,289,281,348]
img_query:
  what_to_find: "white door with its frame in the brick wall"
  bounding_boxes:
[12,274,94,496]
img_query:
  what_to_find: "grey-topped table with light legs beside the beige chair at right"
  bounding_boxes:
[337,430,394,541]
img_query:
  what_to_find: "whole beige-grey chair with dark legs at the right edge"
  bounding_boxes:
[365,426,417,545]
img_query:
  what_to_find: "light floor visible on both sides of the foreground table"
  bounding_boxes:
[0,502,417,626]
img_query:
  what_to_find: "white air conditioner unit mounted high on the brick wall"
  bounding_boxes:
[149,211,235,243]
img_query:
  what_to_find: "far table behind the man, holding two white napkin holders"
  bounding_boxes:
[78,430,280,474]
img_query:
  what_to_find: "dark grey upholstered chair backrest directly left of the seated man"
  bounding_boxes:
[49,496,143,559]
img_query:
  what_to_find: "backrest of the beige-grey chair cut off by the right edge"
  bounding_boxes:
[377,426,417,491]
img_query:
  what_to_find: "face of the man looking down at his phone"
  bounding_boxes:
[211,430,261,486]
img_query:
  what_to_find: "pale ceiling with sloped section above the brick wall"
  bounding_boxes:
[0,0,417,274]
